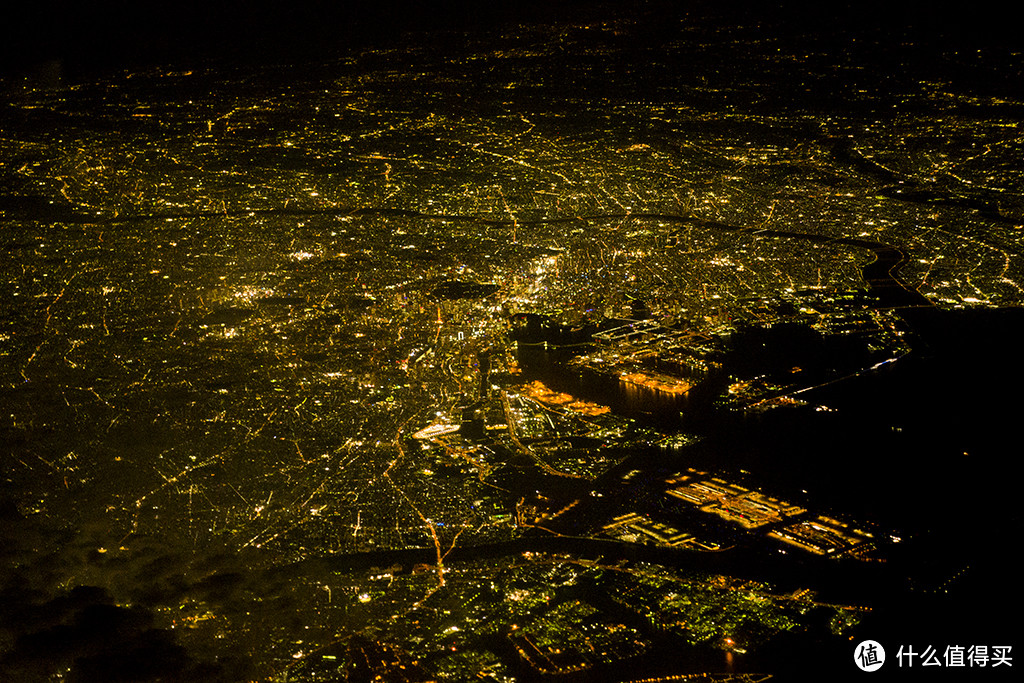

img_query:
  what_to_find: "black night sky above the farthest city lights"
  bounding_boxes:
[0,0,1022,80]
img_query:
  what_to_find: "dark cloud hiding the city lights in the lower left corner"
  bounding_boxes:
[0,499,251,683]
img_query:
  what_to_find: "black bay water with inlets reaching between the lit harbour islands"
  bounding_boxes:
[512,309,1024,680]
